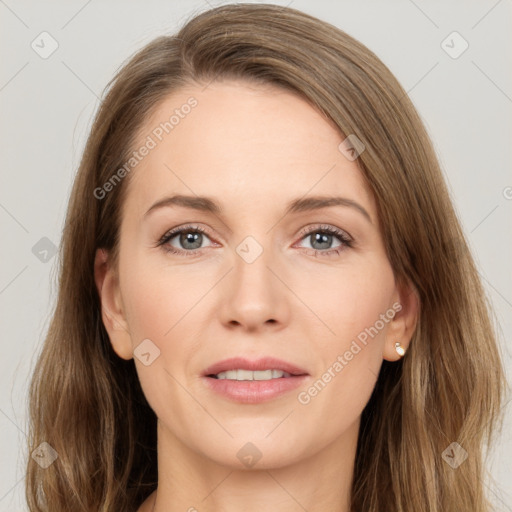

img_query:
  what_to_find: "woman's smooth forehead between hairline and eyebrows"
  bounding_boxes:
[122,81,371,221]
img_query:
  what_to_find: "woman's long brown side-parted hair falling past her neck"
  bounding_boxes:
[26,4,505,512]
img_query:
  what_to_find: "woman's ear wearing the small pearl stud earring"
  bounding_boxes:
[384,283,420,361]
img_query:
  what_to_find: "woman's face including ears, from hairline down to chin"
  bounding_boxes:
[96,81,413,467]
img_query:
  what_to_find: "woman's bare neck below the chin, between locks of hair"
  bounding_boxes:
[146,419,359,512]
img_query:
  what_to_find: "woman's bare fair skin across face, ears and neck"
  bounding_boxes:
[95,81,418,512]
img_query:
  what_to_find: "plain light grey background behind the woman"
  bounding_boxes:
[0,0,512,512]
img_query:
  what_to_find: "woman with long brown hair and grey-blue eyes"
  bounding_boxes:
[26,4,504,512]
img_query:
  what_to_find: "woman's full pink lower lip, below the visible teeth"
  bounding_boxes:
[204,375,309,404]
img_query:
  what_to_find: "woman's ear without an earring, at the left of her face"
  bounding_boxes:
[94,249,133,360]
